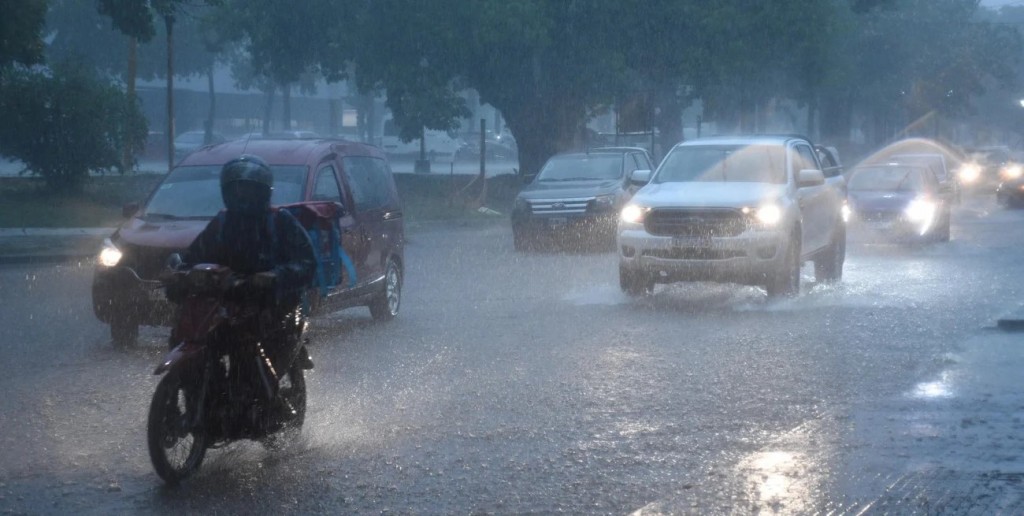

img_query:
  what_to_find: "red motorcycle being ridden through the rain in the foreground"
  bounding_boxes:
[146,257,312,484]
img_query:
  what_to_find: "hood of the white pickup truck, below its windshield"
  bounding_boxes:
[633,181,785,208]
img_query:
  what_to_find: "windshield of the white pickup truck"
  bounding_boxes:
[652,145,785,183]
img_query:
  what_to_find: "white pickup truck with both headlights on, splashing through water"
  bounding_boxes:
[617,135,846,296]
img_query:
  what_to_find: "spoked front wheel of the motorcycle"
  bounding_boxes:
[146,372,207,484]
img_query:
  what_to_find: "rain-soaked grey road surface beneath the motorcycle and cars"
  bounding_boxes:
[0,193,1024,514]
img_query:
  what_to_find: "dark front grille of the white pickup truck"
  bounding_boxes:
[644,208,746,237]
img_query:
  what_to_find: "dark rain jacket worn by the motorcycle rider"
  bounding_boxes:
[182,210,316,312]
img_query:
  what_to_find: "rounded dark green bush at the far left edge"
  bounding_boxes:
[0,65,146,192]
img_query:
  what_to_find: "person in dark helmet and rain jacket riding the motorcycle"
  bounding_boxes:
[174,155,316,415]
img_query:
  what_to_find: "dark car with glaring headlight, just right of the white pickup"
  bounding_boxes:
[847,163,952,242]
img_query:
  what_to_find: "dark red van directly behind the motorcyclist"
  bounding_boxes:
[92,139,404,345]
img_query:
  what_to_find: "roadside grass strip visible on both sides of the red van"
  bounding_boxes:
[0,170,520,227]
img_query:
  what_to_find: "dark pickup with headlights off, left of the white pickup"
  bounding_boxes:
[512,147,652,251]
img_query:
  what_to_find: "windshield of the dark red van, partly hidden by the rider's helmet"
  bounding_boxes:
[144,165,306,219]
